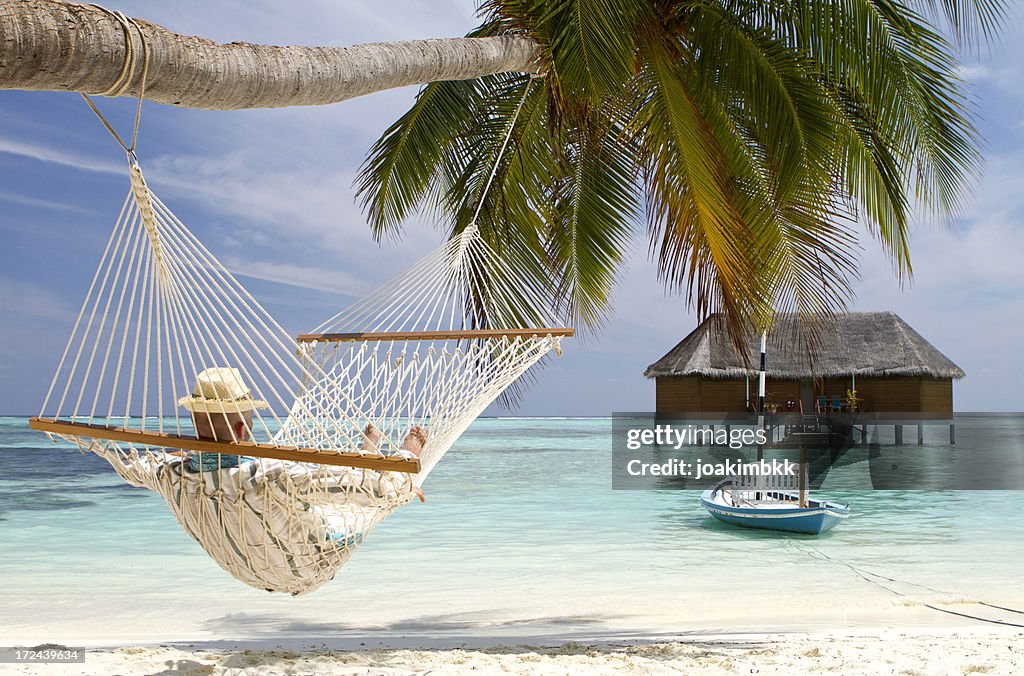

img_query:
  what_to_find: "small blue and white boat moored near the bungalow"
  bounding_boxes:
[700,478,850,535]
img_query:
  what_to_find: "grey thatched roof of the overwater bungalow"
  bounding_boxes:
[644,312,964,379]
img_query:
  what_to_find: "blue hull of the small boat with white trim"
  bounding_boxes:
[700,487,850,535]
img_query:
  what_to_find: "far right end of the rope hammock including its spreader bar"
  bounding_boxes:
[290,226,565,483]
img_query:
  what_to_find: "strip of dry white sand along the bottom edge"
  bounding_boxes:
[9,627,1024,676]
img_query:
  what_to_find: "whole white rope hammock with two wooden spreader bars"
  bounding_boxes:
[30,154,572,595]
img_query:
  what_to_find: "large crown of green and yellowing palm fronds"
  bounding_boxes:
[358,0,1005,356]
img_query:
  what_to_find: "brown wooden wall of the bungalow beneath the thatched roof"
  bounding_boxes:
[655,375,953,414]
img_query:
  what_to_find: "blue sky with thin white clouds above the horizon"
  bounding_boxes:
[0,0,1024,415]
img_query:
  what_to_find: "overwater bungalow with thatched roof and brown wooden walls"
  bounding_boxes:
[644,312,965,417]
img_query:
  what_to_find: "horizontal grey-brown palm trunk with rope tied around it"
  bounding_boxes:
[0,0,539,110]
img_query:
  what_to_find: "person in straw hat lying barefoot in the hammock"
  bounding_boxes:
[104,369,426,595]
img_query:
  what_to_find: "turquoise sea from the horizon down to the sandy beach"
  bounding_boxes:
[0,417,1024,646]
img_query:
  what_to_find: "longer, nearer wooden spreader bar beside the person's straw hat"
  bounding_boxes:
[29,418,420,474]
